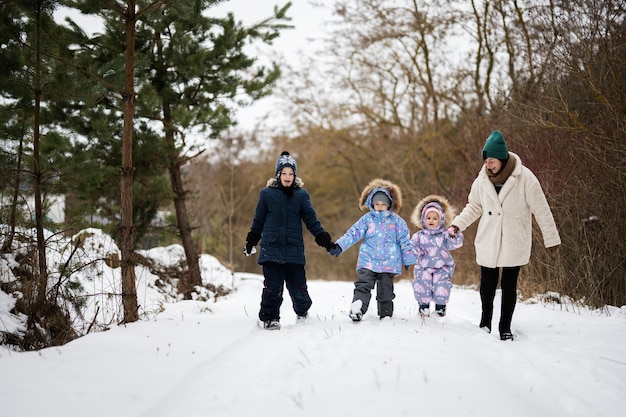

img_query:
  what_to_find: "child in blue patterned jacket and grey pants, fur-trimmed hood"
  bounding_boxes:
[330,178,415,321]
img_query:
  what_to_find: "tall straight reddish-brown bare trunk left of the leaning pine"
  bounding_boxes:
[120,0,139,323]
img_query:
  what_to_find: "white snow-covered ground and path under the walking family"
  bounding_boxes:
[0,230,626,417]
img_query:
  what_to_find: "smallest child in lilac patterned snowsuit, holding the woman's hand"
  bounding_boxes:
[411,195,463,317]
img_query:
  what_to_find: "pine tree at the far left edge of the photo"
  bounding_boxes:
[0,0,90,347]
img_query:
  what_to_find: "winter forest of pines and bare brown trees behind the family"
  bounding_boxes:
[0,0,626,347]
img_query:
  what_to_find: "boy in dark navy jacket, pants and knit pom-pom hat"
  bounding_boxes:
[244,152,334,330]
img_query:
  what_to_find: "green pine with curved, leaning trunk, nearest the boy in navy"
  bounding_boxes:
[131,1,290,296]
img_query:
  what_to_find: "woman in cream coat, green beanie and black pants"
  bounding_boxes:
[452,130,561,340]
